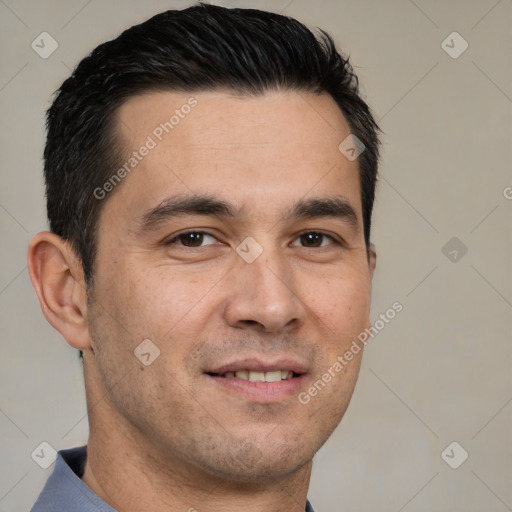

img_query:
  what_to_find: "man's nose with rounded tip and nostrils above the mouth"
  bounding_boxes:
[224,247,306,333]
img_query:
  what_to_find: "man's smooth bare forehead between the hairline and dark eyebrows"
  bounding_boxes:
[104,87,360,222]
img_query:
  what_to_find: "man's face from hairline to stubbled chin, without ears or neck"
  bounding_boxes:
[86,92,371,481]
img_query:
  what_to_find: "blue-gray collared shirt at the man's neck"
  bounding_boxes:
[30,446,314,512]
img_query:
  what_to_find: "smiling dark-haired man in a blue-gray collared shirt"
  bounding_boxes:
[28,4,378,512]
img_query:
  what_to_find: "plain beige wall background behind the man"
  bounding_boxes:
[0,0,512,512]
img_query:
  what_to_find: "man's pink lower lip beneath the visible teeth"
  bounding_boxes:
[205,374,306,403]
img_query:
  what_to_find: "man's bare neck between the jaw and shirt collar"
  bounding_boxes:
[82,364,312,512]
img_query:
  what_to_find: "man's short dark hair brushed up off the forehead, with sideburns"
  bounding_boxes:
[44,3,379,284]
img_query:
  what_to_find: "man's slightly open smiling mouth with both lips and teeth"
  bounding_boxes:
[204,359,307,403]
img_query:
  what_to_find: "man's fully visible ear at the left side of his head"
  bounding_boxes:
[27,231,91,350]
